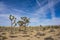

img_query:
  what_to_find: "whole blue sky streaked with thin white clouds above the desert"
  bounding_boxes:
[0,0,60,26]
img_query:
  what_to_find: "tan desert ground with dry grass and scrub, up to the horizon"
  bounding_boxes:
[0,26,60,40]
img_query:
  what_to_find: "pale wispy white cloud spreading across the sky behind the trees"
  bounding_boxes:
[0,0,60,26]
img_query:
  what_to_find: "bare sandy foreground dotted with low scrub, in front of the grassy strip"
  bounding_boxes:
[0,29,60,40]
